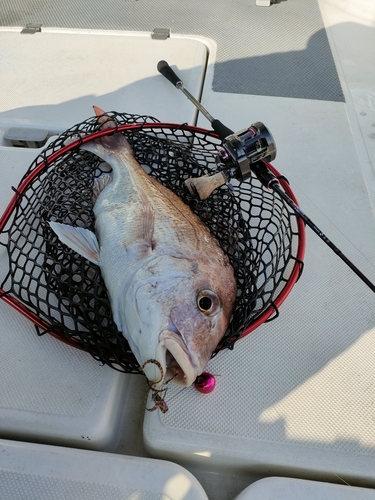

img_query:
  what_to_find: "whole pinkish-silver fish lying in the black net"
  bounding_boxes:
[49,106,237,389]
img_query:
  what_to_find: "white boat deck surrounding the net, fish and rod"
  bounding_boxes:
[0,0,375,500]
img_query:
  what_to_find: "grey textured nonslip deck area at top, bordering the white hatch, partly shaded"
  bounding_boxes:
[0,0,344,101]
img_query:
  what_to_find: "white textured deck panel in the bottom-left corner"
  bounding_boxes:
[0,439,208,500]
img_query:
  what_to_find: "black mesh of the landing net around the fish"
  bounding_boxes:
[1,112,299,373]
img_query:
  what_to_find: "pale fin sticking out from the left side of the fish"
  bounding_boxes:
[49,221,100,265]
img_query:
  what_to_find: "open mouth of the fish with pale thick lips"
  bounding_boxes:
[157,330,199,387]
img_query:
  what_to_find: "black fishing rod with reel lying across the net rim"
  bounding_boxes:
[157,61,375,293]
